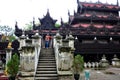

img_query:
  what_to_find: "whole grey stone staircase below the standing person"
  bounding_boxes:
[35,48,58,80]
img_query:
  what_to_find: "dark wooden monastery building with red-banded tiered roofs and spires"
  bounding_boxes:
[15,0,120,62]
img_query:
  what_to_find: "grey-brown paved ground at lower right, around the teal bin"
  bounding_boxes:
[80,68,120,80]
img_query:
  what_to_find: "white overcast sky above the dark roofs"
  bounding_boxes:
[0,0,120,28]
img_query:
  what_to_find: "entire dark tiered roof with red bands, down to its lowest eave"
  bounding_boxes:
[63,0,120,36]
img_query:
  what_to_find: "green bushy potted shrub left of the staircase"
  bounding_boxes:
[6,54,19,80]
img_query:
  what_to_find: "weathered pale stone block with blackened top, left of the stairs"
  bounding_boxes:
[20,46,35,76]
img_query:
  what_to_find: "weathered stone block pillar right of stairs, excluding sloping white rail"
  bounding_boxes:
[58,39,73,80]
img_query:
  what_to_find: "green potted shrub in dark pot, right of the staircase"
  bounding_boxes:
[73,54,84,80]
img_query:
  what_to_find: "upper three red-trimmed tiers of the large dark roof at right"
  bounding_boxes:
[70,0,120,29]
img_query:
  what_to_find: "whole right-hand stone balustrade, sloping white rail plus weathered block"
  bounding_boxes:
[54,34,74,80]
